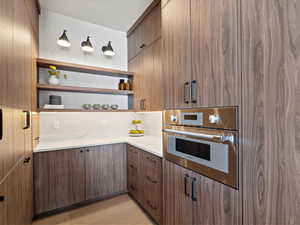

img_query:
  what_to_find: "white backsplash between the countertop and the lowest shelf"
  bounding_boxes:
[40,112,162,143]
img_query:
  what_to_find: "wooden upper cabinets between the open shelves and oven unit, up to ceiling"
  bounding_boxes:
[128,1,163,110]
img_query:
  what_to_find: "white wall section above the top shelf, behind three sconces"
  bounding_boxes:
[39,9,127,70]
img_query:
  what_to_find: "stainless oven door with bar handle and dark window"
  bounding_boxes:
[163,127,238,188]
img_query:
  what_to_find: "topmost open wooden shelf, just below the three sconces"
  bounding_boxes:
[36,58,133,78]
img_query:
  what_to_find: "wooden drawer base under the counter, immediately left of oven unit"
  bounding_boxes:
[128,145,163,224]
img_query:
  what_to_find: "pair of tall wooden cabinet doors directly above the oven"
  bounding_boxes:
[162,0,240,108]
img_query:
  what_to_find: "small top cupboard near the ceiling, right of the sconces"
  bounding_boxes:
[128,5,161,61]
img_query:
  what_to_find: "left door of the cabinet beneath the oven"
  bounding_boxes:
[163,160,194,225]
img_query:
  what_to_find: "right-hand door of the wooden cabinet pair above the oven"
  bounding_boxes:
[191,0,241,107]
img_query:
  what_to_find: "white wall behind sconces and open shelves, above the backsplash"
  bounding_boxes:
[39,10,128,109]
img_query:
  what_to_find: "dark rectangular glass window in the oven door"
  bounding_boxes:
[176,138,210,161]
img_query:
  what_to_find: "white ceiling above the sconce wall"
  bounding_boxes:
[40,0,152,32]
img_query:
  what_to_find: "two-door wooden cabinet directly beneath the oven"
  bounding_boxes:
[164,161,241,225]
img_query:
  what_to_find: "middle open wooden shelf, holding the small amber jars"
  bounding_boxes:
[37,84,134,95]
